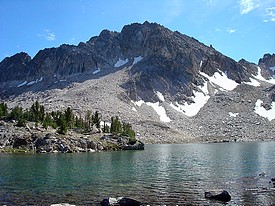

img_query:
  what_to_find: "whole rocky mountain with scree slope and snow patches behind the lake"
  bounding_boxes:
[0,22,275,142]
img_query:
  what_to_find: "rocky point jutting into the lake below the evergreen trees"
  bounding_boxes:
[0,121,144,153]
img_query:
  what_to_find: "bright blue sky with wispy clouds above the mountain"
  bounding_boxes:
[0,0,275,63]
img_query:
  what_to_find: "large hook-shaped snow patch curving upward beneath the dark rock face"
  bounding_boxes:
[170,83,210,117]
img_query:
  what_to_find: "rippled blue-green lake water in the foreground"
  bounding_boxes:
[0,142,275,206]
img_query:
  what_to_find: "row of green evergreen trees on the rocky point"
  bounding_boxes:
[0,101,135,138]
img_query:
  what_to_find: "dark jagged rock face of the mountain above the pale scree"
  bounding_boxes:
[0,22,256,101]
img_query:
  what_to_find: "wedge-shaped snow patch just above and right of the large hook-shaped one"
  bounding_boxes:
[200,71,238,91]
